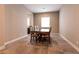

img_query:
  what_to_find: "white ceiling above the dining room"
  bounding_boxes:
[25,4,62,13]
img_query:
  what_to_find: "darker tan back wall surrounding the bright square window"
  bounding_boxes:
[34,12,59,33]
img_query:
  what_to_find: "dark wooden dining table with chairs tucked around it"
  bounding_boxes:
[30,29,50,42]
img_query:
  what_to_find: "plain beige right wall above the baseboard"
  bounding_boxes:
[59,5,79,47]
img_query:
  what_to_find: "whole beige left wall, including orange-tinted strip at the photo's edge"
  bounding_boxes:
[0,4,33,46]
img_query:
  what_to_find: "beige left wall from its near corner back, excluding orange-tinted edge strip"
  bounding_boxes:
[5,5,33,41]
